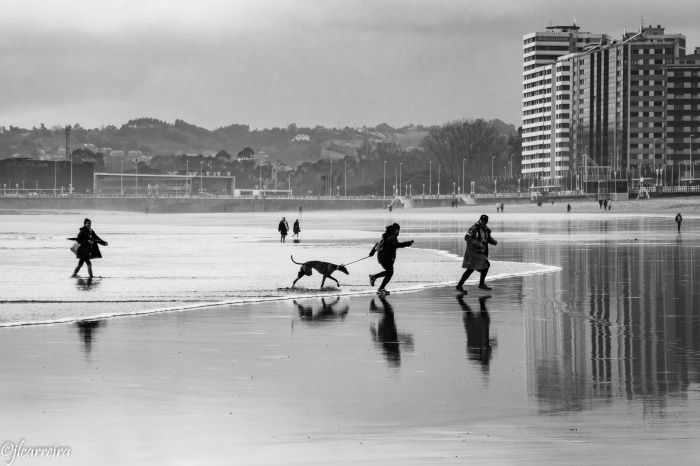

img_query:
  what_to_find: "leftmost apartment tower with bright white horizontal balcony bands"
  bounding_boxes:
[522,24,609,184]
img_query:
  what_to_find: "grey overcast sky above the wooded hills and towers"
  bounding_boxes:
[0,0,700,129]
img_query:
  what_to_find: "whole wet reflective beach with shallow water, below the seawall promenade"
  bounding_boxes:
[0,205,700,465]
